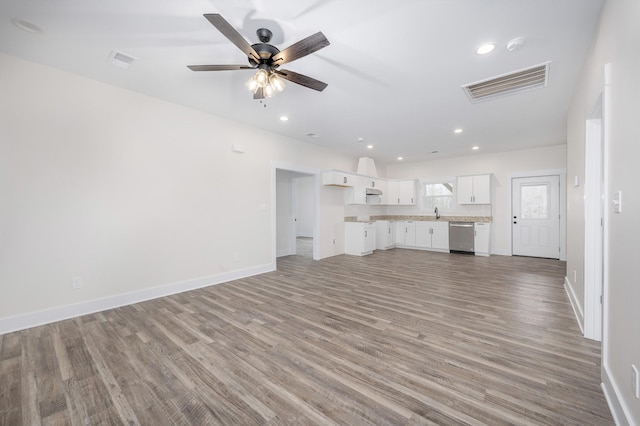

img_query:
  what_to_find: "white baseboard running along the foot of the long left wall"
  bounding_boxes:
[0,263,276,334]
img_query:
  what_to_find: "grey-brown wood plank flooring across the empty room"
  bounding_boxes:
[0,249,613,425]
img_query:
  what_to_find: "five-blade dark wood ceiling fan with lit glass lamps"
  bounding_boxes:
[188,13,329,99]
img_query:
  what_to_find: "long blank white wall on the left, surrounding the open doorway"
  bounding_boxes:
[0,55,357,333]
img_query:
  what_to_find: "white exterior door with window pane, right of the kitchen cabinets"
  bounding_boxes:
[511,176,560,259]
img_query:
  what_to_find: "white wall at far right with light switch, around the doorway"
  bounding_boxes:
[567,0,640,424]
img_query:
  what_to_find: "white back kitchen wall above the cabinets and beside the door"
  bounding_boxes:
[387,145,566,255]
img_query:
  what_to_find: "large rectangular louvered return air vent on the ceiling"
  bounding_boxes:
[462,62,550,103]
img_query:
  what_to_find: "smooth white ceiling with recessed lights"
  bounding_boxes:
[0,0,603,164]
